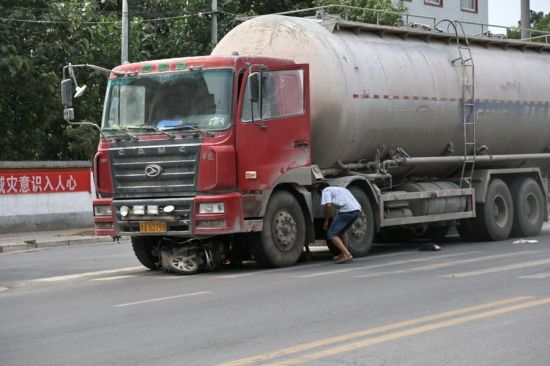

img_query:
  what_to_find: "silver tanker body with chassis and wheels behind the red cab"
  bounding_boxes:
[212,15,550,252]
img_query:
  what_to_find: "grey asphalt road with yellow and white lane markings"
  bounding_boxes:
[0,226,550,366]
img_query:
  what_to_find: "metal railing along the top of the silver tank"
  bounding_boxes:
[237,4,550,44]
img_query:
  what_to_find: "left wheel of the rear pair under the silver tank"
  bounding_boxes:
[474,178,514,241]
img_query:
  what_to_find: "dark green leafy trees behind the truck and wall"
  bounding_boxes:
[0,0,354,160]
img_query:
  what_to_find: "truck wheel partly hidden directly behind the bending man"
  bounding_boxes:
[327,187,374,258]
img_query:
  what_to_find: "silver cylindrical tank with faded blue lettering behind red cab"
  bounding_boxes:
[212,15,550,177]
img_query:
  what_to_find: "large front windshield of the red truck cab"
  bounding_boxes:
[102,70,233,134]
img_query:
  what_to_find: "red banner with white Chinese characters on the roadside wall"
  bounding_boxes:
[0,168,91,195]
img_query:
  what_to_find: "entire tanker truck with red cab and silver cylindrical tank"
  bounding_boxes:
[61,15,550,274]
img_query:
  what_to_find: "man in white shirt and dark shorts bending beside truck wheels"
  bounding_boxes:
[319,183,361,264]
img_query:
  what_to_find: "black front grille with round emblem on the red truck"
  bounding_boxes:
[111,140,201,198]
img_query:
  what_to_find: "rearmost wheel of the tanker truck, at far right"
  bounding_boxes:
[510,177,545,237]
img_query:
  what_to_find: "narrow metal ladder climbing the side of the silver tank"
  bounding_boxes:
[453,22,477,188]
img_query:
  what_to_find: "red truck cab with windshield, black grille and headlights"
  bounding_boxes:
[94,56,311,274]
